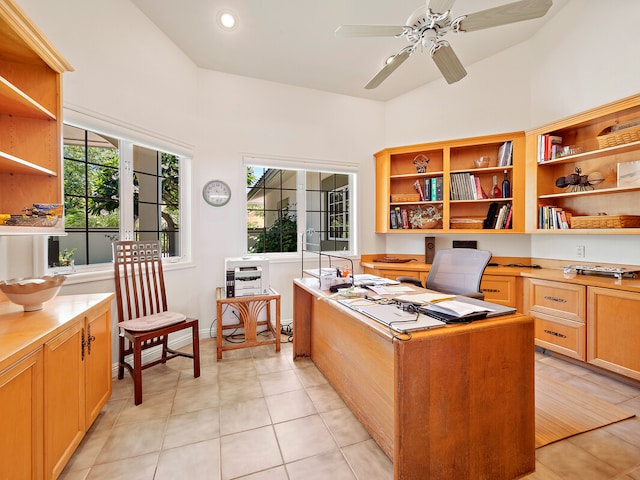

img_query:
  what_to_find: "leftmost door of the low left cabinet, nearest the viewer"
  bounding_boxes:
[0,349,43,479]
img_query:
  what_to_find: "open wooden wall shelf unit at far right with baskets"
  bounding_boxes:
[526,95,640,235]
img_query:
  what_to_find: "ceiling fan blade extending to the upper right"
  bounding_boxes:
[460,0,553,32]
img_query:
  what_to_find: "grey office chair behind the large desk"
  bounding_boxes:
[396,248,491,300]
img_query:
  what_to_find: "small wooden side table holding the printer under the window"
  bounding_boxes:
[216,287,280,360]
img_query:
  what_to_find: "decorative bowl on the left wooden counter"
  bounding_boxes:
[0,275,66,312]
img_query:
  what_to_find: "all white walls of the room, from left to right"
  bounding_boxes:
[7,0,640,338]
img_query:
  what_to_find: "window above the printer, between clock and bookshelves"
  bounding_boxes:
[247,165,354,253]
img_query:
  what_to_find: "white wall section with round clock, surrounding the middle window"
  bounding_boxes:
[193,70,384,326]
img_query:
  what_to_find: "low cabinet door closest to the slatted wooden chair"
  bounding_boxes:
[85,308,111,428]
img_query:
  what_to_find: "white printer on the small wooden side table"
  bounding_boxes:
[224,256,269,298]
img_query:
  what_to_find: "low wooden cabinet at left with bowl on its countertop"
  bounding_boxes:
[0,294,113,479]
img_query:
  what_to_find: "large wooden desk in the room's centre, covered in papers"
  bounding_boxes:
[293,278,535,480]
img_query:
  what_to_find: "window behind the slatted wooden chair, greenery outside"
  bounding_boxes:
[48,125,186,267]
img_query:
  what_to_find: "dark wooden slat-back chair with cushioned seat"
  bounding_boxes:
[113,240,200,405]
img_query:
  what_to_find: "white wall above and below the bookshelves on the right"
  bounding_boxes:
[378,0,640,265]
